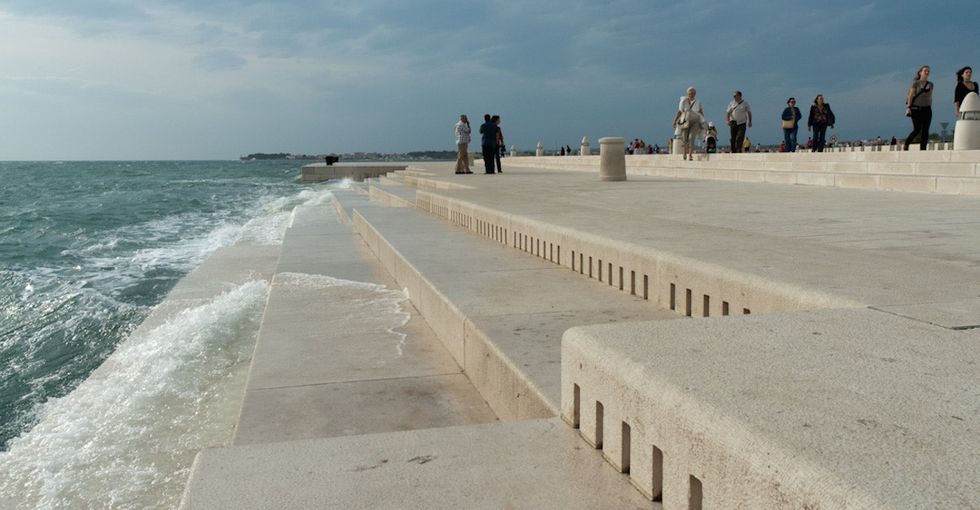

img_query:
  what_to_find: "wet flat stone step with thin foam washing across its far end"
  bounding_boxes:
[234,199,497,445]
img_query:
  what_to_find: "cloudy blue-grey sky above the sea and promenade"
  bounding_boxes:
[0,0,980,160]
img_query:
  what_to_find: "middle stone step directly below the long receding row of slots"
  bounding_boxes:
[340,200,680,420]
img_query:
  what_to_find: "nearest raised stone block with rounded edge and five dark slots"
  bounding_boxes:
[562,309,980,510]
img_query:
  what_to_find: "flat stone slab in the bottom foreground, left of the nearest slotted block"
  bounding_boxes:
[181,418,660,510]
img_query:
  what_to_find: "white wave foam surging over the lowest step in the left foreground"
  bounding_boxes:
[0,281,269,508]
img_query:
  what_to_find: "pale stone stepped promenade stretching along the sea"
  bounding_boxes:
[184,152,980,509]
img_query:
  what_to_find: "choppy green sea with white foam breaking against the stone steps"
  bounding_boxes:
[0,160,345,509]
